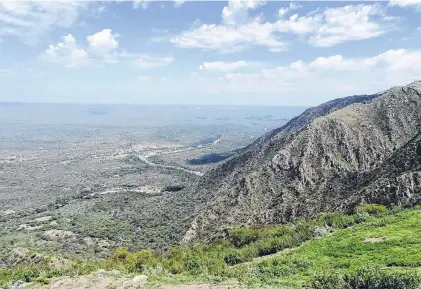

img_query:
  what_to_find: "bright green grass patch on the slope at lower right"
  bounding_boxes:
[226,210,421,288]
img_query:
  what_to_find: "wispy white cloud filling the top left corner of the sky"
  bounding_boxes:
[0,1,89,45]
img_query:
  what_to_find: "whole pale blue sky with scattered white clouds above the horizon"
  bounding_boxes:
[0,0,421,106]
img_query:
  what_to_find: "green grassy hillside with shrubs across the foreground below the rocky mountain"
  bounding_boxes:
[0,205,421,289]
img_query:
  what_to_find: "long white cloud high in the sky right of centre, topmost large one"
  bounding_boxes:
[170,2,394,52]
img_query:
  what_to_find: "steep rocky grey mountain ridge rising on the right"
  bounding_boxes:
[183,81,421,242]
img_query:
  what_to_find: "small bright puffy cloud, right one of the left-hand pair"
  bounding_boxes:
[41,34,90,67]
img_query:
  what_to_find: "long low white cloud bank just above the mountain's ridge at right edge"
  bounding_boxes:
[189,49,421,105]
